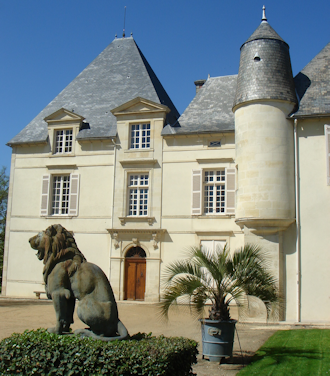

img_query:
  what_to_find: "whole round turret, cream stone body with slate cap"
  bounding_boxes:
[233,7,297,226]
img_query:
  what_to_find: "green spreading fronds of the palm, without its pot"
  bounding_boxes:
[160,245,279,320]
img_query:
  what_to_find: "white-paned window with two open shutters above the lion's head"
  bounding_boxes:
[40,174,79,216]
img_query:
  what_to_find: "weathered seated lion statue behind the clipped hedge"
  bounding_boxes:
[29,225,128,341]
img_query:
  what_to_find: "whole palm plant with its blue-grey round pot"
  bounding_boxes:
[160,245,279,362]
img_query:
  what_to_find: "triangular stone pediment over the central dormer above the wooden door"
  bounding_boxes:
[111,97,170,116]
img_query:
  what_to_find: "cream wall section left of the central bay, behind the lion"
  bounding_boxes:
[2,128,114,297]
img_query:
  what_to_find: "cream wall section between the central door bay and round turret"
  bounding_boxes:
[162,133,242,254]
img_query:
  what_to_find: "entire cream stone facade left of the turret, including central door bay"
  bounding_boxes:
[4,107,242,302]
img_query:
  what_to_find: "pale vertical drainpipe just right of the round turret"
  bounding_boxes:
[294,119,301,322]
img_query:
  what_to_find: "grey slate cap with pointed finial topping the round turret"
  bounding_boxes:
[233,8,297,110]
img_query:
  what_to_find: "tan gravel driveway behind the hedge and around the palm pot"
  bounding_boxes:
[0,298,279,376]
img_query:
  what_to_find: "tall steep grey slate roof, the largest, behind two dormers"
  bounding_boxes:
[8,37,179,146]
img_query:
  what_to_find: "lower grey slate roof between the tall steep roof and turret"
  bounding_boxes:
[162,75,237,136]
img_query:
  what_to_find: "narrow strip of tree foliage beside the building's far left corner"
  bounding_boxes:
[0,167,9,288]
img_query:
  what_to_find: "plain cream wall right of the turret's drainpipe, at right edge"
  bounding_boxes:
[297,117,330,322]
